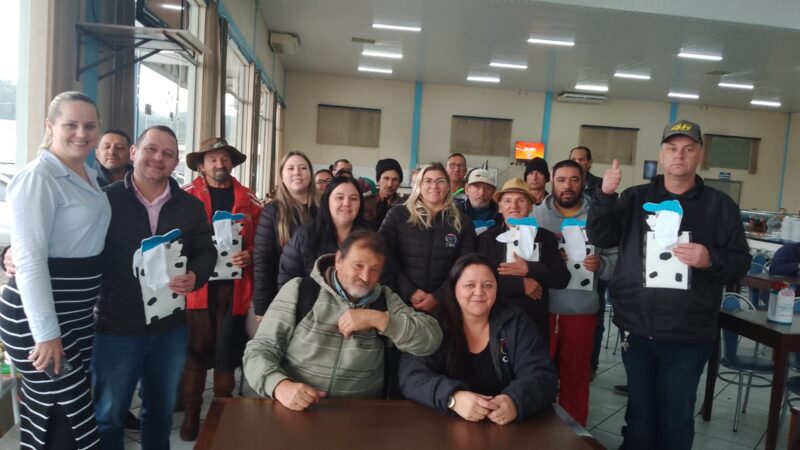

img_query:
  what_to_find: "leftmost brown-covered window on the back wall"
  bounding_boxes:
[317,105,381,147]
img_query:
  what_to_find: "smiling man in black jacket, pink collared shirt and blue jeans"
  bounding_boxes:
[92,126,217,448]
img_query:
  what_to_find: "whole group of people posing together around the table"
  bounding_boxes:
[0,88,749,448]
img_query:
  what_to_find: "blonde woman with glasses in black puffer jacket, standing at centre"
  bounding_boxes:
[379,163,477,312]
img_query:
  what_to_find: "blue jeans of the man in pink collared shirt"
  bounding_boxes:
[92,327,187,450]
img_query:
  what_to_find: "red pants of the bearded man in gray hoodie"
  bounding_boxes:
[550,314,597,427]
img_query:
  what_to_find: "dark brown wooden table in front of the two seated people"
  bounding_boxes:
[195,398,603,450]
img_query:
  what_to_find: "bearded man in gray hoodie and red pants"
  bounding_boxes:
[533,160,617,426]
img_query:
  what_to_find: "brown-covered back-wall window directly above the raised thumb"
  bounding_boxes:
[578,125,639,165]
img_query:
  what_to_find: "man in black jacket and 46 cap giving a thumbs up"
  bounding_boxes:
[588,120,750,449]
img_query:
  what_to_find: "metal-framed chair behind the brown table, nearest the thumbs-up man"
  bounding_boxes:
[717,292,774,431]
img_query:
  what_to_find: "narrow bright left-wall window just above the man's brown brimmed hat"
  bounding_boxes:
[225,39,247,180]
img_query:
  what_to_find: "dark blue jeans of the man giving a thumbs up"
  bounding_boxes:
[620,334,712,450]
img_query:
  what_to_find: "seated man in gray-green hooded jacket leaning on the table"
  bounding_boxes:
[244,230,442,411]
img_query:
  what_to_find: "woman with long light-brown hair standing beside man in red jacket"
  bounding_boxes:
[253,151,319,320]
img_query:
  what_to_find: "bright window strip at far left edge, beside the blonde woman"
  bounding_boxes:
[0,0,19,175]
